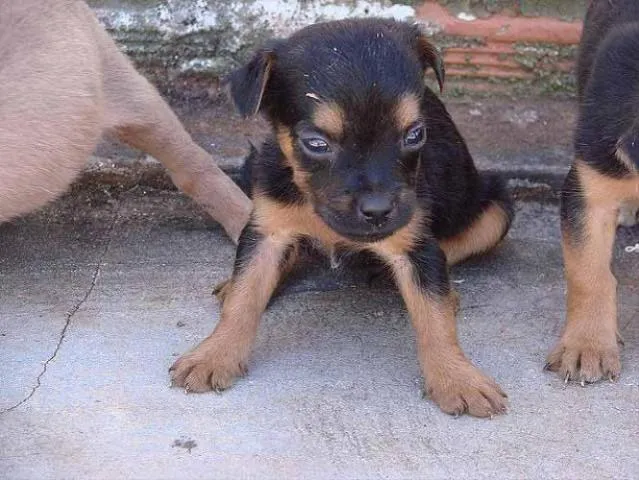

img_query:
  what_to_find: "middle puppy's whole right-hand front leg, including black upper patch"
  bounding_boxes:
[376,240,506,417]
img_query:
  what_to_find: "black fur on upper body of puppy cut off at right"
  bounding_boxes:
[575,0,639,178]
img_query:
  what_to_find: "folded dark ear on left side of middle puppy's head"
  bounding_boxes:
[227,50,275,117]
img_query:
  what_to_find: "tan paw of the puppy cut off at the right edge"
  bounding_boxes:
[544,333,621,386]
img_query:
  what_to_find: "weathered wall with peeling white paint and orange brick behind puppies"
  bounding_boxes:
[89,0,587,94]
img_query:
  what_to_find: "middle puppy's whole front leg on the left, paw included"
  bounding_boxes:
[169,224,293,392]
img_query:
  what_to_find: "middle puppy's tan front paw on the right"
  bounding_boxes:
[426,363,507,418]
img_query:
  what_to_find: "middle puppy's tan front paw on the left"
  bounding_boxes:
[169,346,247,393]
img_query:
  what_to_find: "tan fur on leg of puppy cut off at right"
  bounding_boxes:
[548,159,639,382]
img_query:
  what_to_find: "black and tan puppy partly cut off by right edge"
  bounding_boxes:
[546,0,639,384]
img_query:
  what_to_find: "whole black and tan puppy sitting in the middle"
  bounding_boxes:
[171,19,512,417]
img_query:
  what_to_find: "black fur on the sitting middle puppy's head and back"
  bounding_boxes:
[230,19,513,295]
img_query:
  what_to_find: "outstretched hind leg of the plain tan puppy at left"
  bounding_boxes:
[100,26,251,243]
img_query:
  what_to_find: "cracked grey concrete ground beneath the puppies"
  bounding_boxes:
[0,95,639,479]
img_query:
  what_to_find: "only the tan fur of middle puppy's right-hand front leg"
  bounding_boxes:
[378,247,506,417]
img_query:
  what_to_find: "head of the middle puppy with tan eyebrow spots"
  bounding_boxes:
[230,19,444,242]
